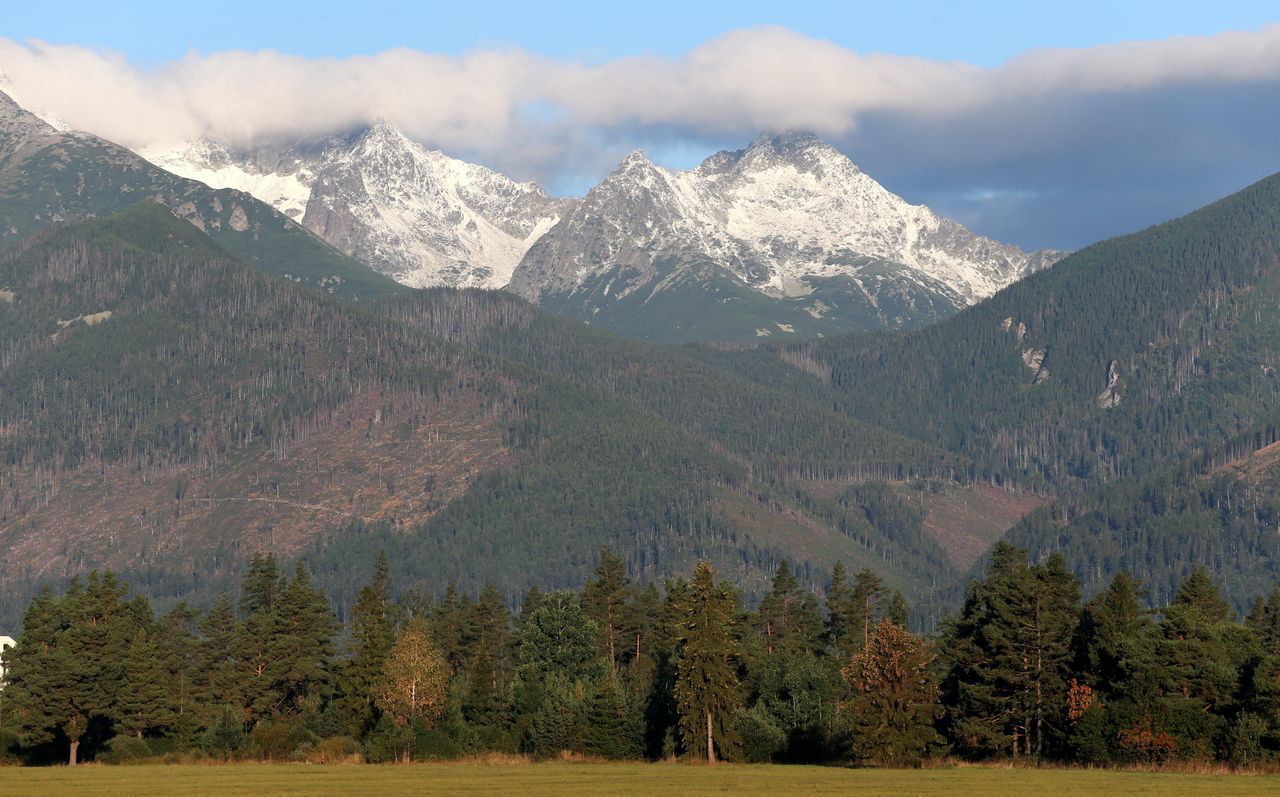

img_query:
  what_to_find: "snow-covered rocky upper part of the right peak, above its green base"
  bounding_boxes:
[511,134,1061,313]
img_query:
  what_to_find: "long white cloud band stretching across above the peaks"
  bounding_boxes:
[0,26,1280,151]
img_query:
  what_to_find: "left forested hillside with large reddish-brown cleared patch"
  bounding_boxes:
[0,205,955,622]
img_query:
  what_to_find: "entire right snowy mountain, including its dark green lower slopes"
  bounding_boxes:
[511,134,1060,340]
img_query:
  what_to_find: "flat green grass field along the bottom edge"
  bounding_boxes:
[0,762,1280,797]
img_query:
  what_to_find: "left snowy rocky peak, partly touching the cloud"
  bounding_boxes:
[145,123,571,288]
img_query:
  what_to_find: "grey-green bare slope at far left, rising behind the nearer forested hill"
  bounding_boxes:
[0,88,402,297]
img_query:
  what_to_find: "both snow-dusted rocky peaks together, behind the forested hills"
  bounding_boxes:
[143,123,1061,342]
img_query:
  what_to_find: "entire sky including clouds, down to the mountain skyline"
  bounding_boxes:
[0,0,1280,248]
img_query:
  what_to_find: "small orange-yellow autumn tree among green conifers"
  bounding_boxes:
[378,620,449,762]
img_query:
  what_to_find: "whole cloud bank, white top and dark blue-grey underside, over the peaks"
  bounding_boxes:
[0,26,1280,246]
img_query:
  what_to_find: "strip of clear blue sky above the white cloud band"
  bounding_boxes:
[10,0,1280,67]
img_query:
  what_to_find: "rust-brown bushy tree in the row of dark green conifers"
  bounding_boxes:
[842,619,943,766]
